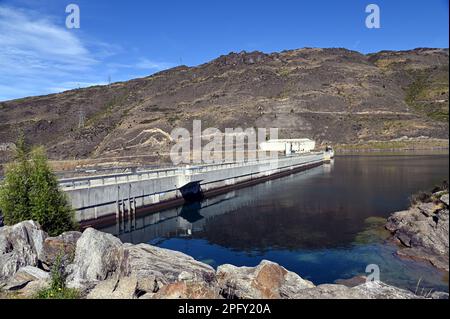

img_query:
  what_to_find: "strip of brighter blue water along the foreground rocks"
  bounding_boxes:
[154,238,448,291]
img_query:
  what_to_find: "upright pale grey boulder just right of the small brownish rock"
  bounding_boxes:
[67,228,123,288]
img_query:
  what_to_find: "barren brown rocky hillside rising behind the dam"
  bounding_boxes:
[0,48,449,161]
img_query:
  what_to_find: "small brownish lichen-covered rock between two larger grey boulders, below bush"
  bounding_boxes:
[39,231,82,268]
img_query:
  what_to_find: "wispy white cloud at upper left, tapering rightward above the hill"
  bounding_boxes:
[0,4,174,101]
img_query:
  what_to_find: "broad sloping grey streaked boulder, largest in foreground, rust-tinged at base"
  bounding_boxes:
[87,244,219,299]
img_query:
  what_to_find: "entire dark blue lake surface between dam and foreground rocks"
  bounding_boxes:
[103,153,449,291]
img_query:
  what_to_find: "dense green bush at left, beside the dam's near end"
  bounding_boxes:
[0,136,76,236]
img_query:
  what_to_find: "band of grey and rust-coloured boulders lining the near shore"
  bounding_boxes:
[0,221,448,299]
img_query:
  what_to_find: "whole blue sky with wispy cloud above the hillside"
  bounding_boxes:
[0,0,449,101]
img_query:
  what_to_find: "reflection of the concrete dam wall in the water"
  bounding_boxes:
[101,164,332,243]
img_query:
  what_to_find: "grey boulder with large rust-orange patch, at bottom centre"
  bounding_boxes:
[217,260,314,299]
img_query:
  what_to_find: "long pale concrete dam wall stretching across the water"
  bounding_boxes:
[59,152,329,227]
